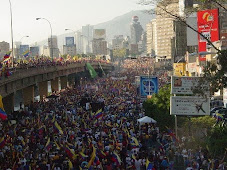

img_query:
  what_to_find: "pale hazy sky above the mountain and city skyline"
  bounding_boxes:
[0,0,148,44]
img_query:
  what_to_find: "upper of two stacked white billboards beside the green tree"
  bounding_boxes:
[171,76,209,95]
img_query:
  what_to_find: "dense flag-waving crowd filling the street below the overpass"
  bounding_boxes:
[0,60,226,170]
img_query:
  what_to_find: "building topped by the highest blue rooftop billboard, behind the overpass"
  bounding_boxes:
[63,37,76,56]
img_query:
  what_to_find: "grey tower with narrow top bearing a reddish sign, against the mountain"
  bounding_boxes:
[130,16,143,44]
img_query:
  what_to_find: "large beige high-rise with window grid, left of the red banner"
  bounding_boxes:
[147,0,187,60]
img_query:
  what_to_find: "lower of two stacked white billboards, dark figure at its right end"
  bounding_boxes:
[170,96,210,116]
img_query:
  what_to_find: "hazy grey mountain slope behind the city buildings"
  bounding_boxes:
[37,10,154,49]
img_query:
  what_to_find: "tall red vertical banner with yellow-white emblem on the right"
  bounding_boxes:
[197,9,219,61]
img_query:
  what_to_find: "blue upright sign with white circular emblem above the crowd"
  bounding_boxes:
[140,76,158,97]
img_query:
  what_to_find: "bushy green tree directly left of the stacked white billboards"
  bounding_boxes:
[143,85,174,130]
